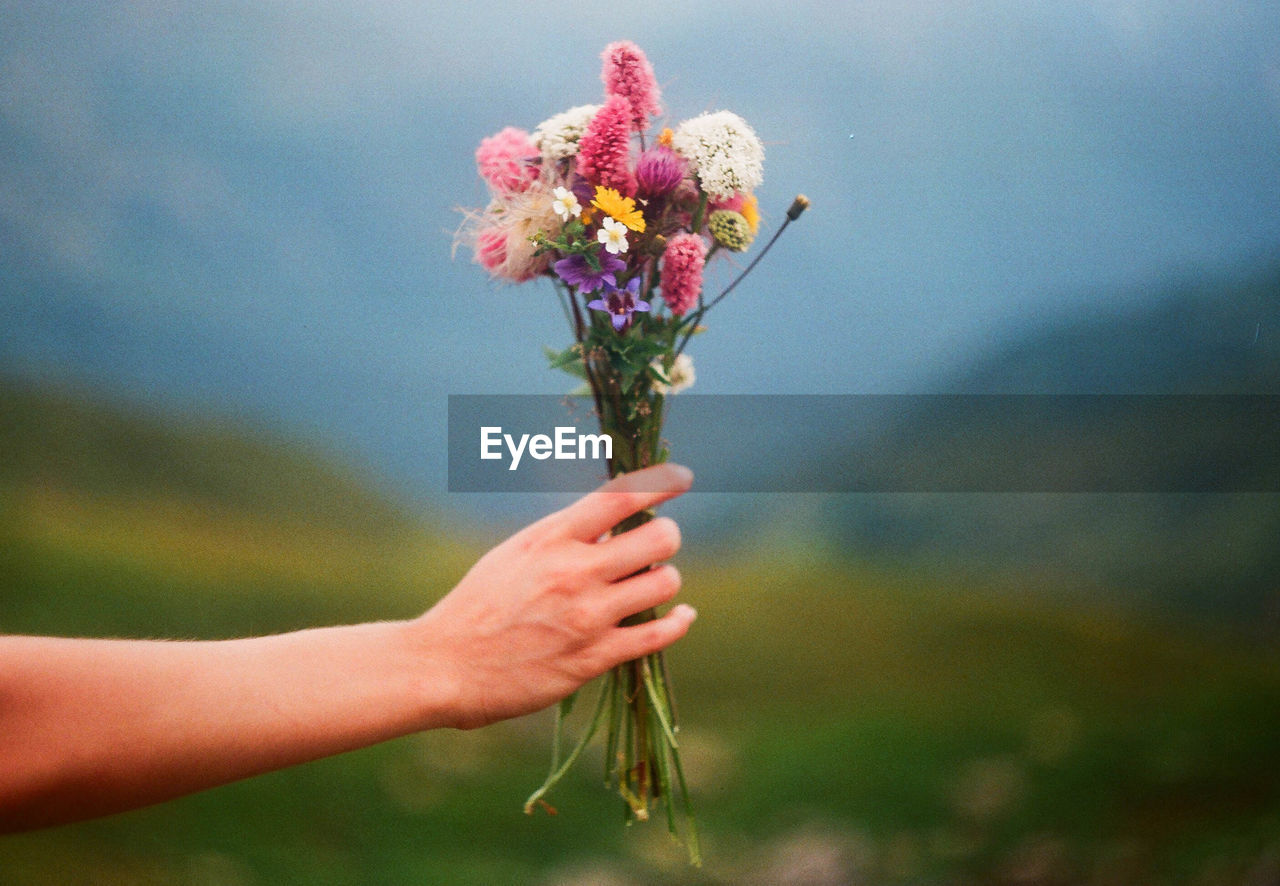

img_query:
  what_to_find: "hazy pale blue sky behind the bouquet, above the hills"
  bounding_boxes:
[0,0,1280,509]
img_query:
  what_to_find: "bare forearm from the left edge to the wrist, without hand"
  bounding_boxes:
[0,622,445,830]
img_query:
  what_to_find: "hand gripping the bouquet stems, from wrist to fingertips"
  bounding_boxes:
[412,463,696,729]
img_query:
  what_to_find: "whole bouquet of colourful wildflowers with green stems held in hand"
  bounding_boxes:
[463,41,808,862]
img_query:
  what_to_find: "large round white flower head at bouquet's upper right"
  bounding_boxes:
[671,111,764,200]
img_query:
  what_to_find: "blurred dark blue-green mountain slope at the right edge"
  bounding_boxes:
[812,259,1280,624]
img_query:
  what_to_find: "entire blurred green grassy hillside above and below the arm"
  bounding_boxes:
[0,376,1280,886]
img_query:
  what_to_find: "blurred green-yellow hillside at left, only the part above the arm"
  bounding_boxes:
[0,380,476,636]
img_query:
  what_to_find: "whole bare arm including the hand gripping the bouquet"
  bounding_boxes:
[0,466,694,831]
